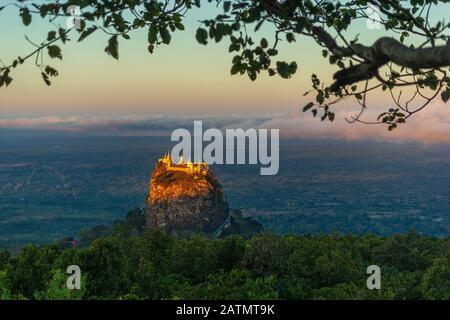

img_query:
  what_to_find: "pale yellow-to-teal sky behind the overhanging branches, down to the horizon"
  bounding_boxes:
[0,0,450,141]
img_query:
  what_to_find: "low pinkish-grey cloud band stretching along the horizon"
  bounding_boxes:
[0,101,450,143]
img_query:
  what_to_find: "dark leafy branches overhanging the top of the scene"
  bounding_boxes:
[0,0,450,130]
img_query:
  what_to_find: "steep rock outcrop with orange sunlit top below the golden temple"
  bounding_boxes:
[147,160,229,233]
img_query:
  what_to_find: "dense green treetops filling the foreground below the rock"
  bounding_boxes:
[0,212,450,299]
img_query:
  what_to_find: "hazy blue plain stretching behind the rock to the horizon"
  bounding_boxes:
[0,133,450,249]
